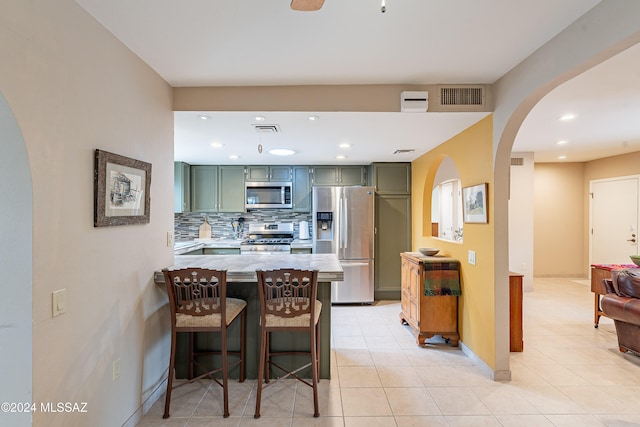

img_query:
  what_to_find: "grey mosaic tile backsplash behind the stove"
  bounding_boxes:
[174,209,311,242]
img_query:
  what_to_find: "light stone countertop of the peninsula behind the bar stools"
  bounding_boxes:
[154,253,344,286]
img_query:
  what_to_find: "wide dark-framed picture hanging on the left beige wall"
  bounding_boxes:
[93,149,151,227]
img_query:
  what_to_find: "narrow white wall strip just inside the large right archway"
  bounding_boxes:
[509,152,535,291]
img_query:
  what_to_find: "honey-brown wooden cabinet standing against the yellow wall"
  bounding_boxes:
[400,252,460,346]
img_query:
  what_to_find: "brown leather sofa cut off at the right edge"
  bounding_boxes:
[600,269,640,355]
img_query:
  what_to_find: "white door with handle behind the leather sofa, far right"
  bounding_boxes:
[591,177,640,264]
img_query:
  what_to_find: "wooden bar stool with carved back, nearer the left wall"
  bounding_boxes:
[162,268,247,418]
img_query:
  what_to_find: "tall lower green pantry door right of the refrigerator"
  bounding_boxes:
[374,194,411,300]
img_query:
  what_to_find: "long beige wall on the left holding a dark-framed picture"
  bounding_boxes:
[0,0,173,427]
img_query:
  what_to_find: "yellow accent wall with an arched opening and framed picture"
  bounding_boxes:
[411,115,496,369]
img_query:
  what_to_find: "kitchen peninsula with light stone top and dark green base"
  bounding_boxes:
[154,253,344,378]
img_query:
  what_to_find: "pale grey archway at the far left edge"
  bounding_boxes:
[0,94,33,427]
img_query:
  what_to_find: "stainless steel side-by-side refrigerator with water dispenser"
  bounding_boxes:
[312,187,374,303]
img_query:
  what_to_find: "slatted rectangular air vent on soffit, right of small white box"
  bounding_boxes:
[429,85,493,112]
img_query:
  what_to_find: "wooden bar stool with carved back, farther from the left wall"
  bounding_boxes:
[254,269,322,418]
